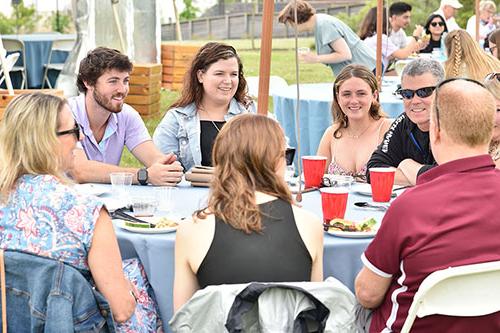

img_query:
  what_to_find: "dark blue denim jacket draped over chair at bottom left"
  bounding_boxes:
[0,251,115,333]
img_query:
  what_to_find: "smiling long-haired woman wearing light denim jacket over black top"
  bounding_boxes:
[153,43,255,171]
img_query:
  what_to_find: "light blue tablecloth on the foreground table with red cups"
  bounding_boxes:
[104,183,383,322]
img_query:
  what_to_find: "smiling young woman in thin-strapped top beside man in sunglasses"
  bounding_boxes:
[317,65,391,180]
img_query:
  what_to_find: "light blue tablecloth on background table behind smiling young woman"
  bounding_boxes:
[273,77,404,163]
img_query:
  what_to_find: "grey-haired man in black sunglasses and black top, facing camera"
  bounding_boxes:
[367,59,444,185]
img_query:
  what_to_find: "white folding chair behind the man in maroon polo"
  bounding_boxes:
[401,261,500,333]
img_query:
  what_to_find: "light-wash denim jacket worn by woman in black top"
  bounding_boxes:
[153,98,255,171]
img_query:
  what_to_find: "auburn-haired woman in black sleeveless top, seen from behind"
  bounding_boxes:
[174,114,323,310]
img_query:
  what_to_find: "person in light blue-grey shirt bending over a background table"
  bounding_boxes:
[278,0,375,75]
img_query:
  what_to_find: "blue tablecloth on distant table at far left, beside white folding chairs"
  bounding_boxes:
[2,34,75,89]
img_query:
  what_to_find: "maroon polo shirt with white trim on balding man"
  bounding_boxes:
[361,155,500,333]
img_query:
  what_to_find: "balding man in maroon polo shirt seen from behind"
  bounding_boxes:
[355,79,500,333]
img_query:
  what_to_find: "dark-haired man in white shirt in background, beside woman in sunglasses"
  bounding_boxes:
[389,2,423,49]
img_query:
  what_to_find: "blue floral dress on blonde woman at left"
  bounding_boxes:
[0,175,163,332]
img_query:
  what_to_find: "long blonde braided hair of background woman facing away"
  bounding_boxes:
[444,30,500,82]
